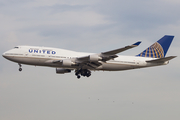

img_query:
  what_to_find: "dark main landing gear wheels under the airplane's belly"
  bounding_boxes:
[75,69,91,79]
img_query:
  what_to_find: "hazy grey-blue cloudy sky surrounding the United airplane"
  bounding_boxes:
[0,0,180,120]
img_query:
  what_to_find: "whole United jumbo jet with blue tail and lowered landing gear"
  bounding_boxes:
[2,35,177,79]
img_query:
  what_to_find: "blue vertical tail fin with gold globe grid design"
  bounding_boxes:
[137,35,174,58]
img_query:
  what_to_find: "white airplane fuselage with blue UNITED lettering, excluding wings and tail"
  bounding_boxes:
[3,46,168,71]
